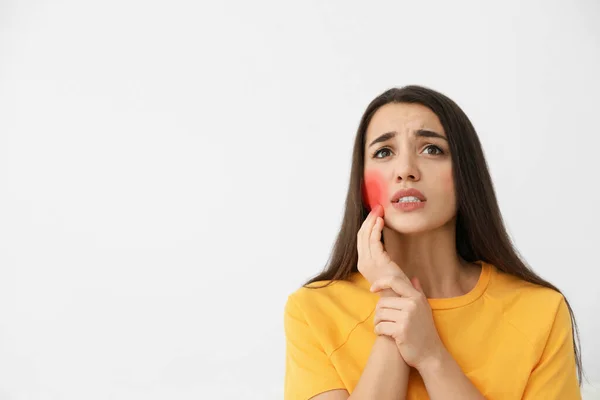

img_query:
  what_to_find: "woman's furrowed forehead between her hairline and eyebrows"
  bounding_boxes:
[367,103,446,142]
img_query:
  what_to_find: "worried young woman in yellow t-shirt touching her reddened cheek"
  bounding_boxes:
[284,86,582,400]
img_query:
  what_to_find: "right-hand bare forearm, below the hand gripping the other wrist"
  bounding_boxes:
[419,349,485,400]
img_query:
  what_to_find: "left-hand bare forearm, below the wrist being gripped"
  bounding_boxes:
[349,292,410,400]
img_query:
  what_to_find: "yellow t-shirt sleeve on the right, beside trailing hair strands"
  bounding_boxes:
[523,298,581,400]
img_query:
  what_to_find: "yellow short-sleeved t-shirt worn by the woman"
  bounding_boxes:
[284,262,581,400]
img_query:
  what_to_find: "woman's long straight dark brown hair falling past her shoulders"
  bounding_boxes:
[304,85,583,384]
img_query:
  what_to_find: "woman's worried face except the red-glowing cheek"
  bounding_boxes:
[364,103,456,234]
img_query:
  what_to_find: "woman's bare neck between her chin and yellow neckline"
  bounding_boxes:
[383,221,481,298]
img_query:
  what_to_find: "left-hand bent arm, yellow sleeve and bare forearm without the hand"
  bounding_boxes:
[284,294,409,400]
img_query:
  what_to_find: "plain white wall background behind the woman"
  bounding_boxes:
[0,0,600,400]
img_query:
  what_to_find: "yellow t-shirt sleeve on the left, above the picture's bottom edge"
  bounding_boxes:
[284,296,345,400]
